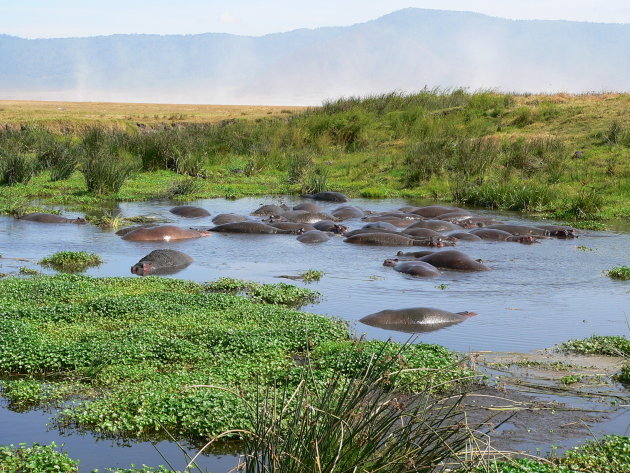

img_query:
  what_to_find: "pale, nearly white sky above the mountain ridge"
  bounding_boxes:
[0,0,630,38]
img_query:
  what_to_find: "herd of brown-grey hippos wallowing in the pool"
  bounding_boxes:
[13,192,577,332]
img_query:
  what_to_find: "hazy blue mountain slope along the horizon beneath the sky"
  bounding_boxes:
[0,8,630,104]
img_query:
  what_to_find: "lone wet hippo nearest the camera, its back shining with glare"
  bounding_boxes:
[359,307,478,333]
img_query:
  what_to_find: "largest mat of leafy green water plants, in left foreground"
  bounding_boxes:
[0,274,472,440]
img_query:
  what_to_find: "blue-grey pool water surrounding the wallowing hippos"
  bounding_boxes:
[0,197,630,471]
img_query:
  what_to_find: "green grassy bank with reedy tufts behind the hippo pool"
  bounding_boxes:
[0,90,630,220]
